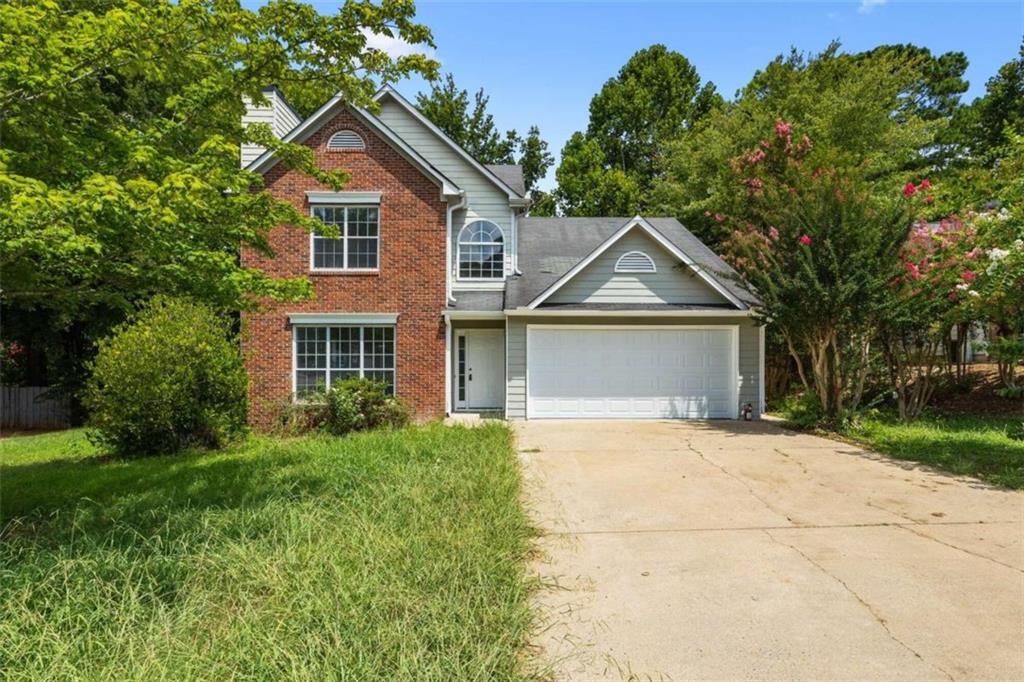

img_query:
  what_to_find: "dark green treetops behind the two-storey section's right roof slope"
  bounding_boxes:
[416,74,554,191]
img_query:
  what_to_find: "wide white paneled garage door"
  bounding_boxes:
[526,326,738,419]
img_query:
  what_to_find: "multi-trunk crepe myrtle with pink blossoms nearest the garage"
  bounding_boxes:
[709,120,928,425]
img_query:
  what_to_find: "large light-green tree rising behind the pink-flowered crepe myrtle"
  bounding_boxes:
[651,44,958,243]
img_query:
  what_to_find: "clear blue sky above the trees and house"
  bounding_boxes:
[299,0,1024,187]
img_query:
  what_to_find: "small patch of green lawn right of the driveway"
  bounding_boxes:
[844,415,1024,488]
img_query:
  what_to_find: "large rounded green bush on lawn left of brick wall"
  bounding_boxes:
[83,297,247,456]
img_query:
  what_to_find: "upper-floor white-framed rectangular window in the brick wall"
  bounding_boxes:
[309,206,380,270]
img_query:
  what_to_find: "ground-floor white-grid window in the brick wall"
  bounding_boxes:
[292,325,395,398]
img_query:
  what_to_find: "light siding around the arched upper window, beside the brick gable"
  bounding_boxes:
[379,97,514,276]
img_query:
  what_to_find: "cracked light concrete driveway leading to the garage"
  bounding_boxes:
[517,421,1024,680]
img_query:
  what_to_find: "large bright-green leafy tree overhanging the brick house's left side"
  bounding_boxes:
[0,0,436,393]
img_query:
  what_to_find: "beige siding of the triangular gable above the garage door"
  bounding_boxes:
[546,227,728,305]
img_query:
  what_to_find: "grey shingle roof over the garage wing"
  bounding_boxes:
[505,217,757,308]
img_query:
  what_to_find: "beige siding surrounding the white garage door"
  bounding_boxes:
[505,315,761,419]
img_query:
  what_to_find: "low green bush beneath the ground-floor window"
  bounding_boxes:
[325,378,409,435]
